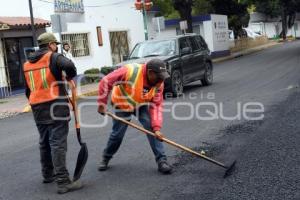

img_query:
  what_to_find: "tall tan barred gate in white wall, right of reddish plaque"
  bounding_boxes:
[109,31,129,64]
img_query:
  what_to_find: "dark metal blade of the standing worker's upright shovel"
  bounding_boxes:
[73,143,88,181]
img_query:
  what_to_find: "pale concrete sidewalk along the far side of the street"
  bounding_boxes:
[0,42,280,119]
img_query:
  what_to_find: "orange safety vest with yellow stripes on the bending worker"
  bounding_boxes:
[111,64,160,111]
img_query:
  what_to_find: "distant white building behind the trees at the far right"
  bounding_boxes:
[248,12,300,38]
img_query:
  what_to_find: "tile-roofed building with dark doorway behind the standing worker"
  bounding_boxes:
[0,17,50,98]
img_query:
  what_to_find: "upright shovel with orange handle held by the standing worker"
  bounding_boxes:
[67,80,88,181]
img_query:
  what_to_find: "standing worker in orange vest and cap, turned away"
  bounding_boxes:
[24,33,82,194]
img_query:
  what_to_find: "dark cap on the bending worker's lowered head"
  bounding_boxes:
[146,58,170,80]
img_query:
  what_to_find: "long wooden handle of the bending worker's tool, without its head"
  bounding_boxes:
[106,112,227,169]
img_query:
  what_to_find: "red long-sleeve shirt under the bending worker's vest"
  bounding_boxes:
[98,65,164,131]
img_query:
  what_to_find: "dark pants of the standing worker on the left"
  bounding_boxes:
[37,121,70,185]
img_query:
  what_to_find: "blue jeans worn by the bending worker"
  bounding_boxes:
[103,106,166,162]
